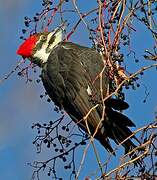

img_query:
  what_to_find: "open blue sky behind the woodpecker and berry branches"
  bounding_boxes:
[0,0,157,180]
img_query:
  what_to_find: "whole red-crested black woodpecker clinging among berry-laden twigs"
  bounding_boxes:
[17,28,136,153]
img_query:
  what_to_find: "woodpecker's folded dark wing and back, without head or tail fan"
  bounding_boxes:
[42,43,112,151]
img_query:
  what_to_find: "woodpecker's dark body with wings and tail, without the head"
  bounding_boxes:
[42,43,139,155]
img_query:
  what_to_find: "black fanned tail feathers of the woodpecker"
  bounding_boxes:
[99,107,141,165]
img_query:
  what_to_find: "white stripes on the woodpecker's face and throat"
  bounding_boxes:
[34,31,62,63]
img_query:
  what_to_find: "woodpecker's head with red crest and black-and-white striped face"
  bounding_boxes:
[16,28,63,66]
